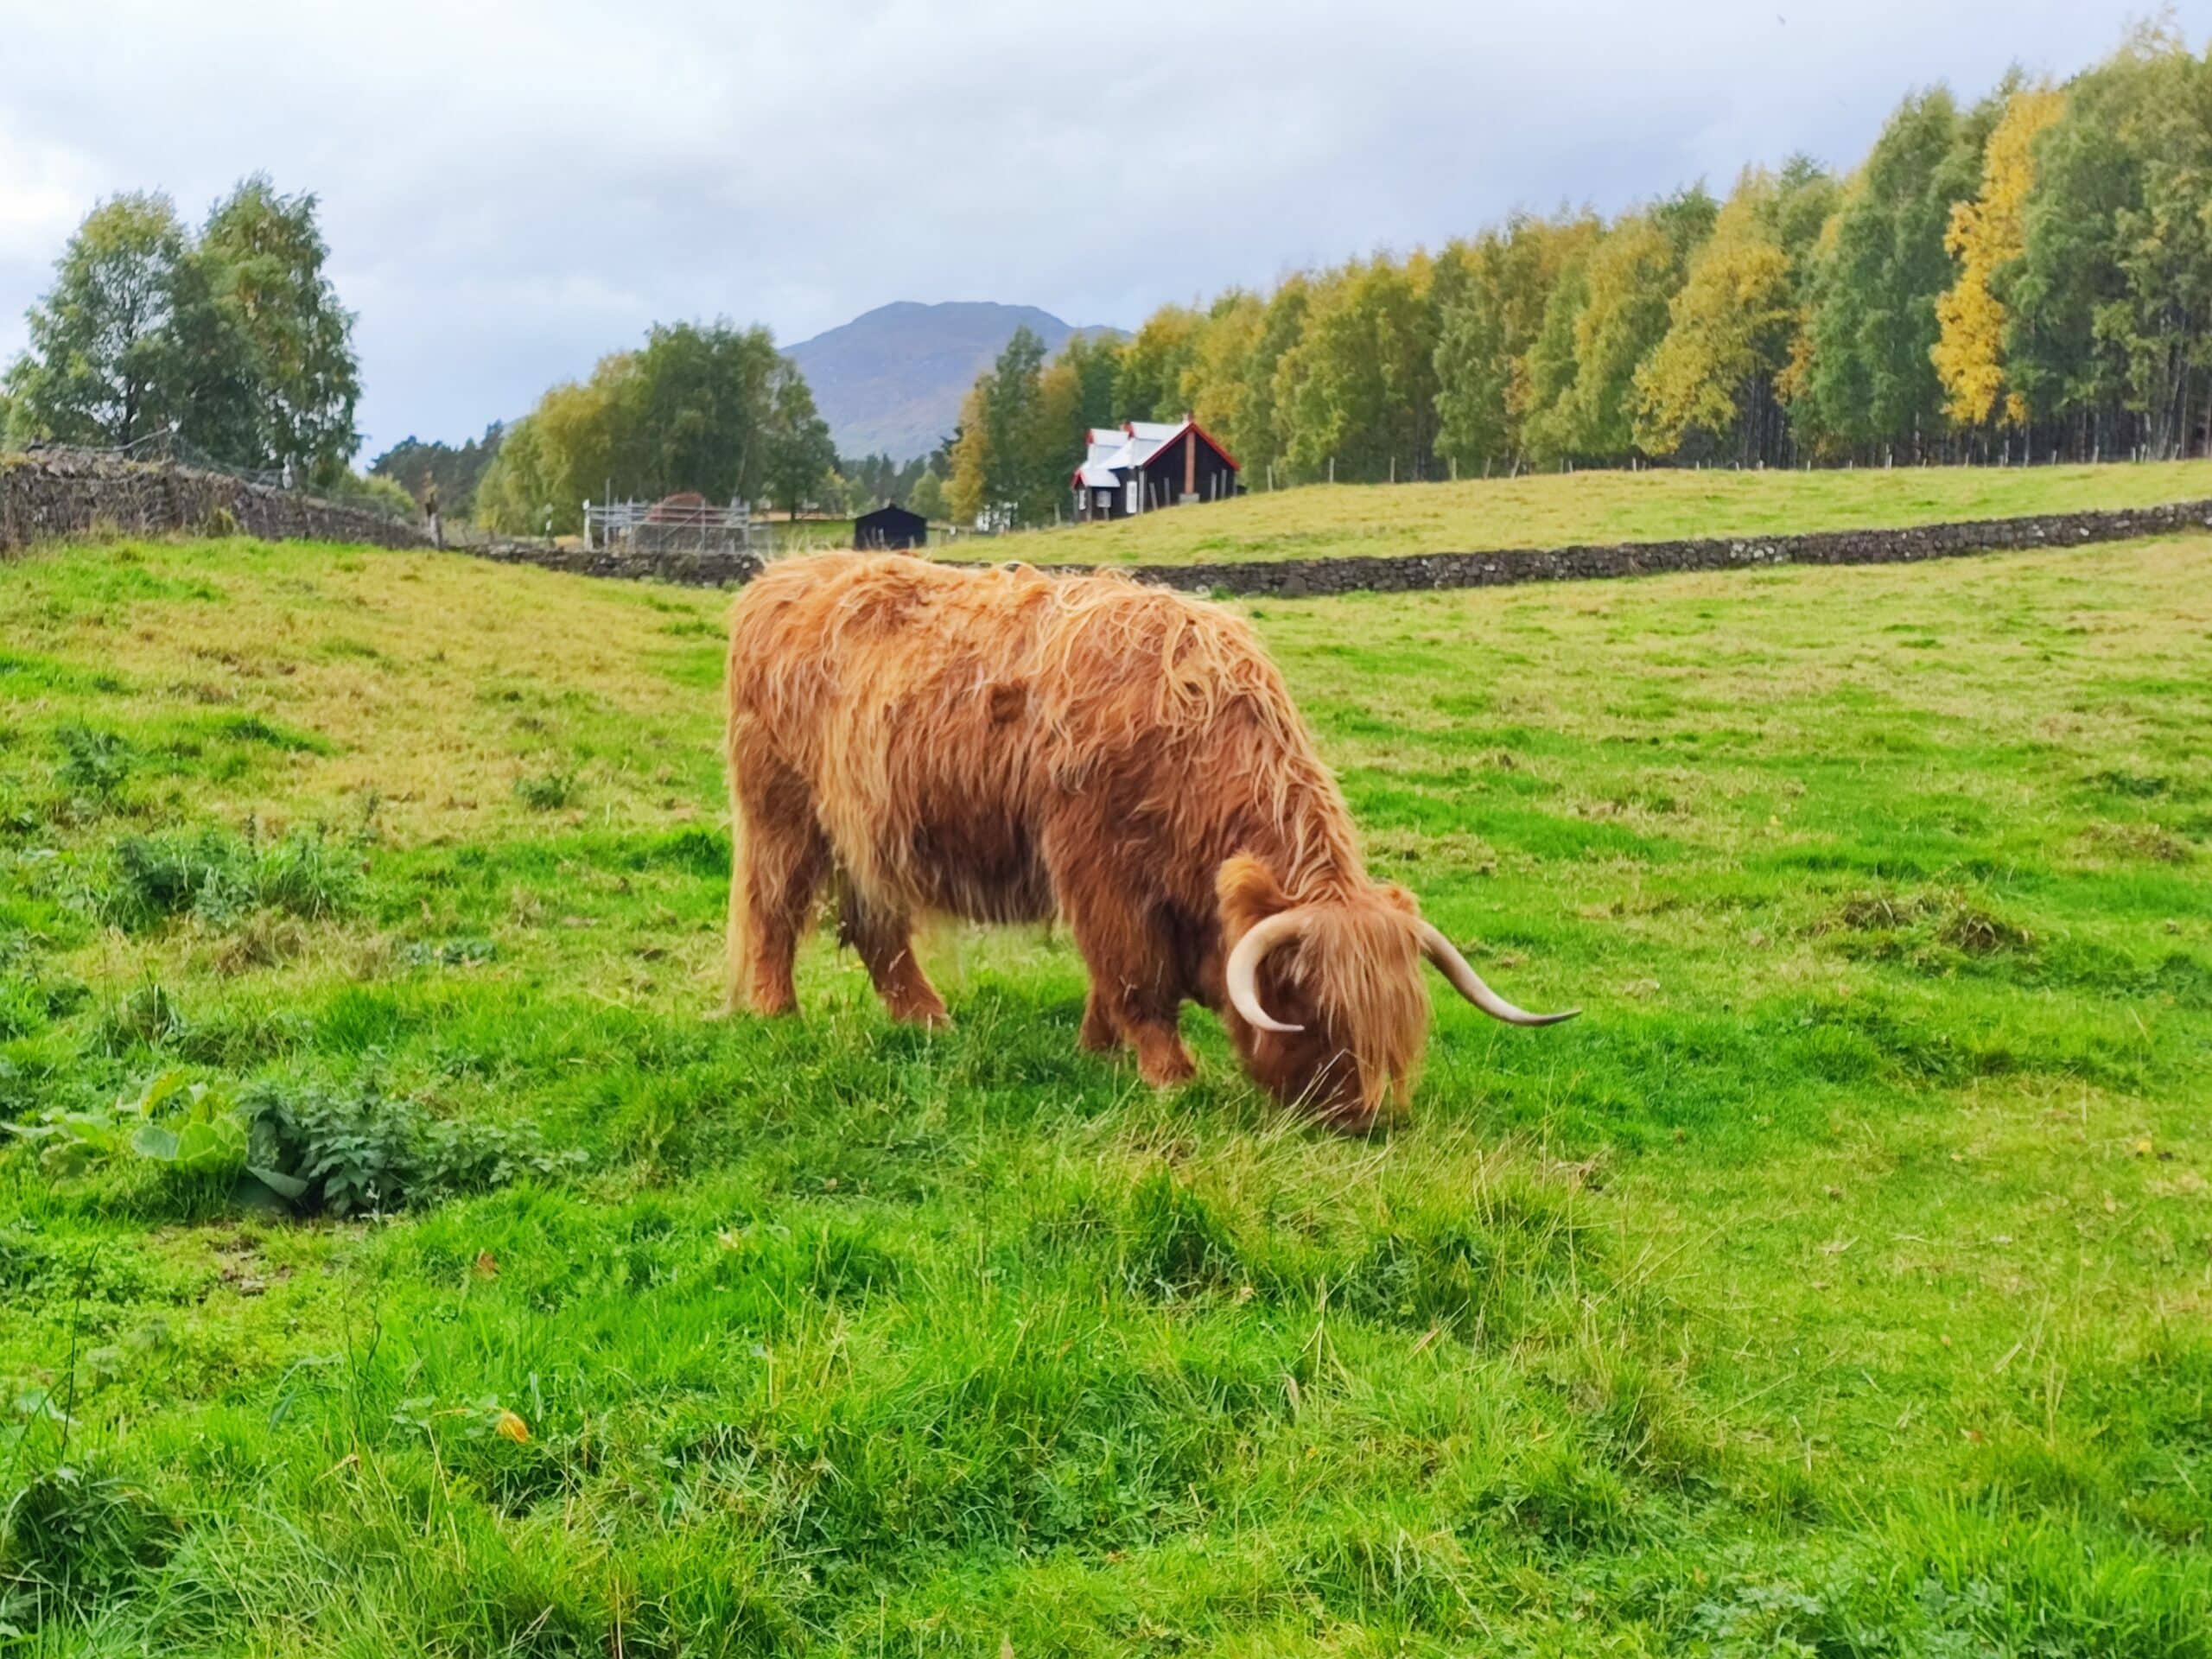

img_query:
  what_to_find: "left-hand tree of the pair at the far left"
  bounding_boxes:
[9,193,250,458]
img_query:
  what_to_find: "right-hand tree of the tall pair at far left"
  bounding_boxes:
[197,173,360,482]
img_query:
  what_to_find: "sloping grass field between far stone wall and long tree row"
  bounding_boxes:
[988,460,2212,564]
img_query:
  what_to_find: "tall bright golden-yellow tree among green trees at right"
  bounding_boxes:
[1931,86,2066,427]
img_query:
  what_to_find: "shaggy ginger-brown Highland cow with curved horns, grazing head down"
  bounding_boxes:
[728,553,1568,1128]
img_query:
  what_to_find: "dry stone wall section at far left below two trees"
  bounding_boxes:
[0,449,427,553]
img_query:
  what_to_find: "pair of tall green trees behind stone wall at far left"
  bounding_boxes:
[0,173,360,486]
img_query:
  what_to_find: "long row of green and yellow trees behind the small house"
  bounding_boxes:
[949,24,2212,524]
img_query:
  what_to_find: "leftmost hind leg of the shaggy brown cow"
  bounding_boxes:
[728,747,830,1013]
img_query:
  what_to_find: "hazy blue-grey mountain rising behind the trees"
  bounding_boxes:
[785,299,1122,460]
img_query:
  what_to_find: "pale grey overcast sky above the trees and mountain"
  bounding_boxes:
[0,0,2212,458]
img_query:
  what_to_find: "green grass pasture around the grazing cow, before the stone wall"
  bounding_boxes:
[0,539,2212,1659]
